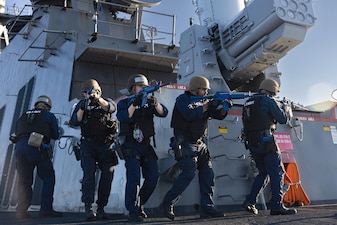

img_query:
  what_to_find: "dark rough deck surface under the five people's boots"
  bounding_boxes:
[0,205,337,225]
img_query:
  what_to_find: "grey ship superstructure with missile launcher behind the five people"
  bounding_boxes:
[0,0,337,216]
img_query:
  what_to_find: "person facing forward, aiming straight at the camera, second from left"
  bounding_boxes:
[71,79,118,221]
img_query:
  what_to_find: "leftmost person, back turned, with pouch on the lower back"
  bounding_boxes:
[11,95,62,218]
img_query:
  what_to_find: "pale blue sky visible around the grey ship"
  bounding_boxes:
[6,0,337,106]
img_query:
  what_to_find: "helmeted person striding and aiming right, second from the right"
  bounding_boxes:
[160,76,228,220]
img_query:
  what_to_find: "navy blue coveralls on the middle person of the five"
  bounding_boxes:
[117,98,168,215]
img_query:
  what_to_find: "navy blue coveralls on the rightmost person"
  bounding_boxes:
[243,93,289,210]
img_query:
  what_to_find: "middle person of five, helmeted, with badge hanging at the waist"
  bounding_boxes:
[117,74,168,222]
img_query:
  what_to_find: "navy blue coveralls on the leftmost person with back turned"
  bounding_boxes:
[15,109,59,213]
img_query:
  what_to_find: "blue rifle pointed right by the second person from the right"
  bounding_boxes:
[189,91,252,111]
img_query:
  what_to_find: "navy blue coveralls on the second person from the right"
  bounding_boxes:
[163,91,227,212]
